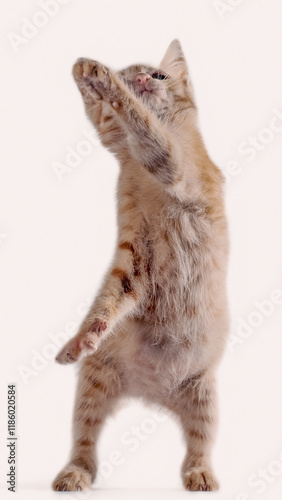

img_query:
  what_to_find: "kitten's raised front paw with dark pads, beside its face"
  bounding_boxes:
[73,58,112,99]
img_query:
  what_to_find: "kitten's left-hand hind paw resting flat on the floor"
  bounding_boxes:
[52,464,92,491]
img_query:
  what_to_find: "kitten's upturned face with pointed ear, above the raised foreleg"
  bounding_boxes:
[118,40,194,116]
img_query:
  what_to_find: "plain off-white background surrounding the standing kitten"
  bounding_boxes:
[0,0,282,500]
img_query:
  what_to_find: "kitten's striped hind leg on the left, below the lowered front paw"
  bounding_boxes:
[52,355,122,491]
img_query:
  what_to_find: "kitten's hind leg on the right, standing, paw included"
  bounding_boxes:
[166,373,219,491]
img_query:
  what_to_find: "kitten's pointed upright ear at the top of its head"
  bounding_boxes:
[160,39,188,80]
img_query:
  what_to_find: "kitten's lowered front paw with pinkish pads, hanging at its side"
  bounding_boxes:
[56,319,107,365]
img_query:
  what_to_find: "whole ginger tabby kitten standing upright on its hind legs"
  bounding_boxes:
[53,40,228,491]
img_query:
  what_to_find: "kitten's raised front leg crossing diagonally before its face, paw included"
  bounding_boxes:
[73,59,182,186]
